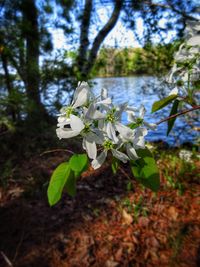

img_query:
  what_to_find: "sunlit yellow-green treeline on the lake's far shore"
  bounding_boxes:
[92,43,180,77]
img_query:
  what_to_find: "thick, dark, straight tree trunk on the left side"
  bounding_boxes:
[21,0,47,122]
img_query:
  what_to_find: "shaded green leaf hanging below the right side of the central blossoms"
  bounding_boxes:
[130,149,160,191]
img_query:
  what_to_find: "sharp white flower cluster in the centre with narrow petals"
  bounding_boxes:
[56,82,156,169]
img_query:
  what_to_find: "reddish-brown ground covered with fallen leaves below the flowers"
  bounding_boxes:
[0,153,200,267]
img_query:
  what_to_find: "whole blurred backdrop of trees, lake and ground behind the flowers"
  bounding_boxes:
[0,0,200,267]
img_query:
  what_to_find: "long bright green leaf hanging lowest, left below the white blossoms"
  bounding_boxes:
[47,162,71,206]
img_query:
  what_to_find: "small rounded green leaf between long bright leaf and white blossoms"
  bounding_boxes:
[69,154,88,176]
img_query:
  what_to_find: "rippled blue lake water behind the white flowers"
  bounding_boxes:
[92,76,199,145]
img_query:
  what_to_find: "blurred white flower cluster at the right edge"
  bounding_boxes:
[167,21,200,96]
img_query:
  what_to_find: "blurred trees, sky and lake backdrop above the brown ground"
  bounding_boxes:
[0,0,199,145]
